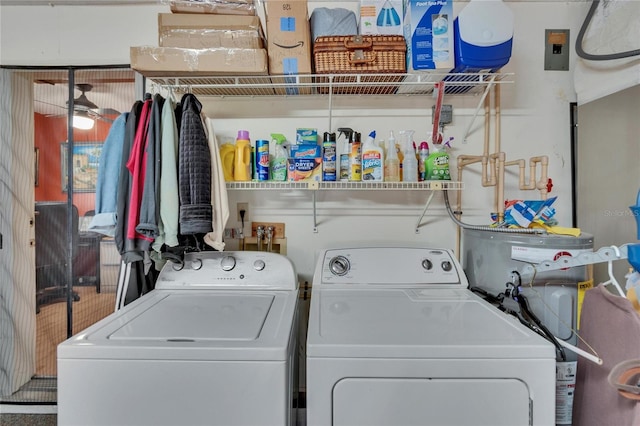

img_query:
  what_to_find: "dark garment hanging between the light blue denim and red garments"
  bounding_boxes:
[115,101,143,262]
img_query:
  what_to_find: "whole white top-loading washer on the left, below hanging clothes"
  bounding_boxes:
[58,252,298,426]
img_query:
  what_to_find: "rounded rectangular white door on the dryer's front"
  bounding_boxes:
[333,378,531,426]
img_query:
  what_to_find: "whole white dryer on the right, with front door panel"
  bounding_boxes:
[307,248,556,426]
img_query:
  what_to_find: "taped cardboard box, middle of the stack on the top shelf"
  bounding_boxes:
[158,13,265,49]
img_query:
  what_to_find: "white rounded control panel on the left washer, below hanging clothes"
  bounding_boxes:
[156,251,298,290]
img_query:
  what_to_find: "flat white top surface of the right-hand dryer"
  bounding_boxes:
[307,288,555,359]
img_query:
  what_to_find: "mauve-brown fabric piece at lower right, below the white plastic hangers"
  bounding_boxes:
[573,284,640,426]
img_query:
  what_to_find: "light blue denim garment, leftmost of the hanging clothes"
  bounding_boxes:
[88,112,129,237]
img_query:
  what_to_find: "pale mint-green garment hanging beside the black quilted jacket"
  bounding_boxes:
[152,97,180,253]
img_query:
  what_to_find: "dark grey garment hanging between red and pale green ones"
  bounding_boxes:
[136,94,164,246]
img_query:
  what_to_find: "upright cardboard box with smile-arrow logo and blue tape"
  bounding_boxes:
[264,0,312,75]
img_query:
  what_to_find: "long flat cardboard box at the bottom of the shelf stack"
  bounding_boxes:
[130,46,268,77]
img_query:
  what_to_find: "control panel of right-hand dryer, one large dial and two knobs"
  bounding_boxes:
[313,247,468,288]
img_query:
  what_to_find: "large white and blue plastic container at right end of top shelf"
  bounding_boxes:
[451,0,513,73]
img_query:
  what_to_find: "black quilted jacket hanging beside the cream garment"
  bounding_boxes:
[178,93,213,235]
